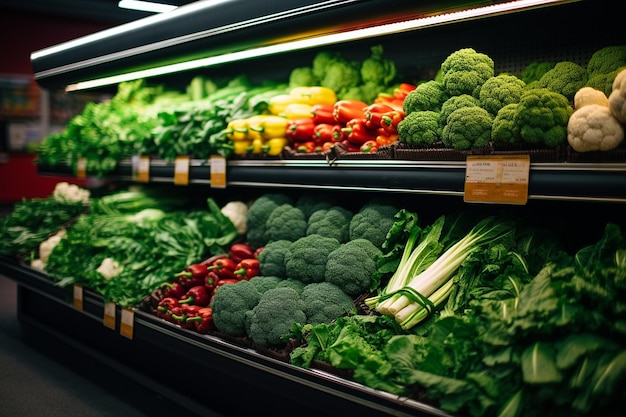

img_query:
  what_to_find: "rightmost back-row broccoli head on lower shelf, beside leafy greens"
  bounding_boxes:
[350,199,398,248]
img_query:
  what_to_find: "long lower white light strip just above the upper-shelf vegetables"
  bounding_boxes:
[65,0,576,92]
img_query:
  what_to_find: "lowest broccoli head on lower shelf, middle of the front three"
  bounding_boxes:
[246,287,306,347]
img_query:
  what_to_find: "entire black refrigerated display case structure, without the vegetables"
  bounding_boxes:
[0,0,626,416]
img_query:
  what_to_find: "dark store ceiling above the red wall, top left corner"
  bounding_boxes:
[0,0,194,26]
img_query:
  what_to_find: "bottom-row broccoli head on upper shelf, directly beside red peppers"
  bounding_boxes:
[398,110,442,146]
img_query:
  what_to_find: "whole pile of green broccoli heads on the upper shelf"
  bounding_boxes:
[398,45,626,158]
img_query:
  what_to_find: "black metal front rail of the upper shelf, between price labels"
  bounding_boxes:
[39,156,626,203]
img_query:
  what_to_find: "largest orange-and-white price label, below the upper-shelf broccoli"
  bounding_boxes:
[463,154,530,204]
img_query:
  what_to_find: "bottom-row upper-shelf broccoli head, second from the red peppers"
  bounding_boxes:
[441,107,493,151]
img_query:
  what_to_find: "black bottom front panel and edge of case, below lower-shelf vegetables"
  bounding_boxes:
[0,257,447,417]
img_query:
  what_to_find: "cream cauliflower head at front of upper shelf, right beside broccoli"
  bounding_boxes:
[567,104,624,152]
